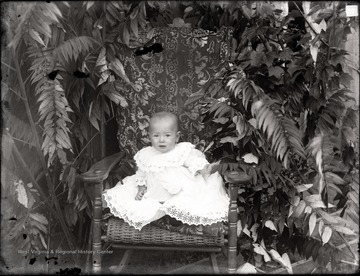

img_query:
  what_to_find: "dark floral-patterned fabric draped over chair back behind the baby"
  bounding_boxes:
[117,27,231,155]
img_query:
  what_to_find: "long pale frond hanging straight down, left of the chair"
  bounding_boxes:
[37,78,72,166]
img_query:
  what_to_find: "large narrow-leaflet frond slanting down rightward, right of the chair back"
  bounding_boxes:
[251,99,305,168]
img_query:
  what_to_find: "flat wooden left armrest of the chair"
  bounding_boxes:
[80,152,126,183]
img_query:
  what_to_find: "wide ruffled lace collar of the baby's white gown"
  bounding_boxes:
[134,142,195,172]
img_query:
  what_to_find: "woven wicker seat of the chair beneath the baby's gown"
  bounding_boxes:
[106,218,224,247]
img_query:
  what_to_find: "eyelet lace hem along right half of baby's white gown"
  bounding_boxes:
[164,206,228,225]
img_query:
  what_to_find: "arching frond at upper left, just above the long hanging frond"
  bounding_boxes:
[54,36,99,64]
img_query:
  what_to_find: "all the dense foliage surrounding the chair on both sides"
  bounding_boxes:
[2,1,359,269]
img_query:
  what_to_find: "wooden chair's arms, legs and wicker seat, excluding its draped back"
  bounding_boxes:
[81,152,250,273]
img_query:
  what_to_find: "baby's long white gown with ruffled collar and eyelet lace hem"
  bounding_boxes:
[103,142,229,230]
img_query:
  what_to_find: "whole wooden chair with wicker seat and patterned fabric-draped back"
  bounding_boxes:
[82,27,249,273]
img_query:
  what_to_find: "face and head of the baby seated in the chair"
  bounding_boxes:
[150,118,179,153]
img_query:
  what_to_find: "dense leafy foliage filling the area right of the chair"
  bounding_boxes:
[189,3,359,269]
